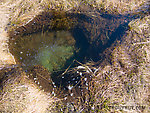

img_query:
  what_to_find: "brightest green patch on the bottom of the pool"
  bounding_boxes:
[38,45,74,72]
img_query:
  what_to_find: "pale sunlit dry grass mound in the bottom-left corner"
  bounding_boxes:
[0,68,58,113]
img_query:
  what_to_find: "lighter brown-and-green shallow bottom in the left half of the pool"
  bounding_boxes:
[10,31,76,72]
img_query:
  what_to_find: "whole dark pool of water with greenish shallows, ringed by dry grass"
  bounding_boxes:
[9,7,139,101]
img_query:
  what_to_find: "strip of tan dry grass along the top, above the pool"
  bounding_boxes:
[1,0,148,26]
